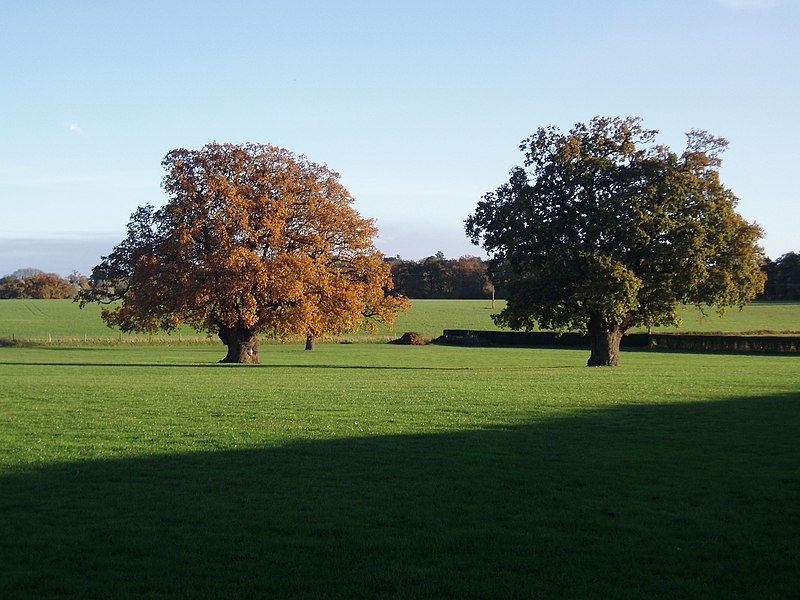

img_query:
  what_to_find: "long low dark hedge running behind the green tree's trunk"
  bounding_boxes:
[434,329,800,354]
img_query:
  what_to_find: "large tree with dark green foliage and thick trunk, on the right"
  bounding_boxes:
[466,117,764,365]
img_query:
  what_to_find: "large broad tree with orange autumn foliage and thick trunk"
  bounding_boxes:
[78,143,408,363]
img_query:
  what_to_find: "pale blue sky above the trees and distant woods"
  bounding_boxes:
[0,0,800,276]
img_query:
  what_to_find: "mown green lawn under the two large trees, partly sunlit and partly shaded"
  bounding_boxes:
[0,344,800,598]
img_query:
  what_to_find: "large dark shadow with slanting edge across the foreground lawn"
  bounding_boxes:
[0,396,800,598]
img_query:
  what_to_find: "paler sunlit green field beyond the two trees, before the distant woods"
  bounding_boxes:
[0,300,800,341]
